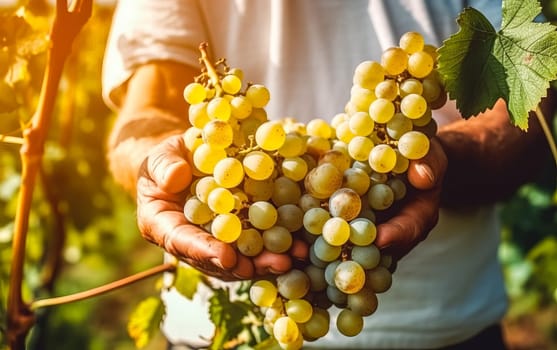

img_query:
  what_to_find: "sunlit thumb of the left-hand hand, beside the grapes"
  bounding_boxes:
[147,136,192,193]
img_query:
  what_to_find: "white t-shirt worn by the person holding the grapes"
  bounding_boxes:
[103,0,507,349]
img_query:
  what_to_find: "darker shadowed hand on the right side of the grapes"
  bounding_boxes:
[375,138,447,267]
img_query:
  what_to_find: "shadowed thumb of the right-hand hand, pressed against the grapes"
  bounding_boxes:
[407,138,447,190]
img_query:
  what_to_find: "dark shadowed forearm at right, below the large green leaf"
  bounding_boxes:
[438,93,554,207]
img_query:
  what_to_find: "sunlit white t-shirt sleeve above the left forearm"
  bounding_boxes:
[102,0,206,109]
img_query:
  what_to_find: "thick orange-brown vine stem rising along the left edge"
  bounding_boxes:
[7,0,93,350]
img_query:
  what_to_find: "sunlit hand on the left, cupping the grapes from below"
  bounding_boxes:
[137,135,307,280]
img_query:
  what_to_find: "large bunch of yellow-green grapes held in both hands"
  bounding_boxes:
[180,32,446,349]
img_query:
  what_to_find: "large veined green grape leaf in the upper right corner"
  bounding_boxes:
[438,0,557,130]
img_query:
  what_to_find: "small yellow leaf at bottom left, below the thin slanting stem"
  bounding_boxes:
[128,297,164,349]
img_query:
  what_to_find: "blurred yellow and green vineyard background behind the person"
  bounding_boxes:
[0,0,557,350]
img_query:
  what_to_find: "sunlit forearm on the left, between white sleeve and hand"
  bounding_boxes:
[108,62,194,195]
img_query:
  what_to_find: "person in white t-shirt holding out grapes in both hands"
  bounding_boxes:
[103,0,547,349]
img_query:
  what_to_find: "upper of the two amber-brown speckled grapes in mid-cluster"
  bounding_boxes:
[304,163,342,198]
